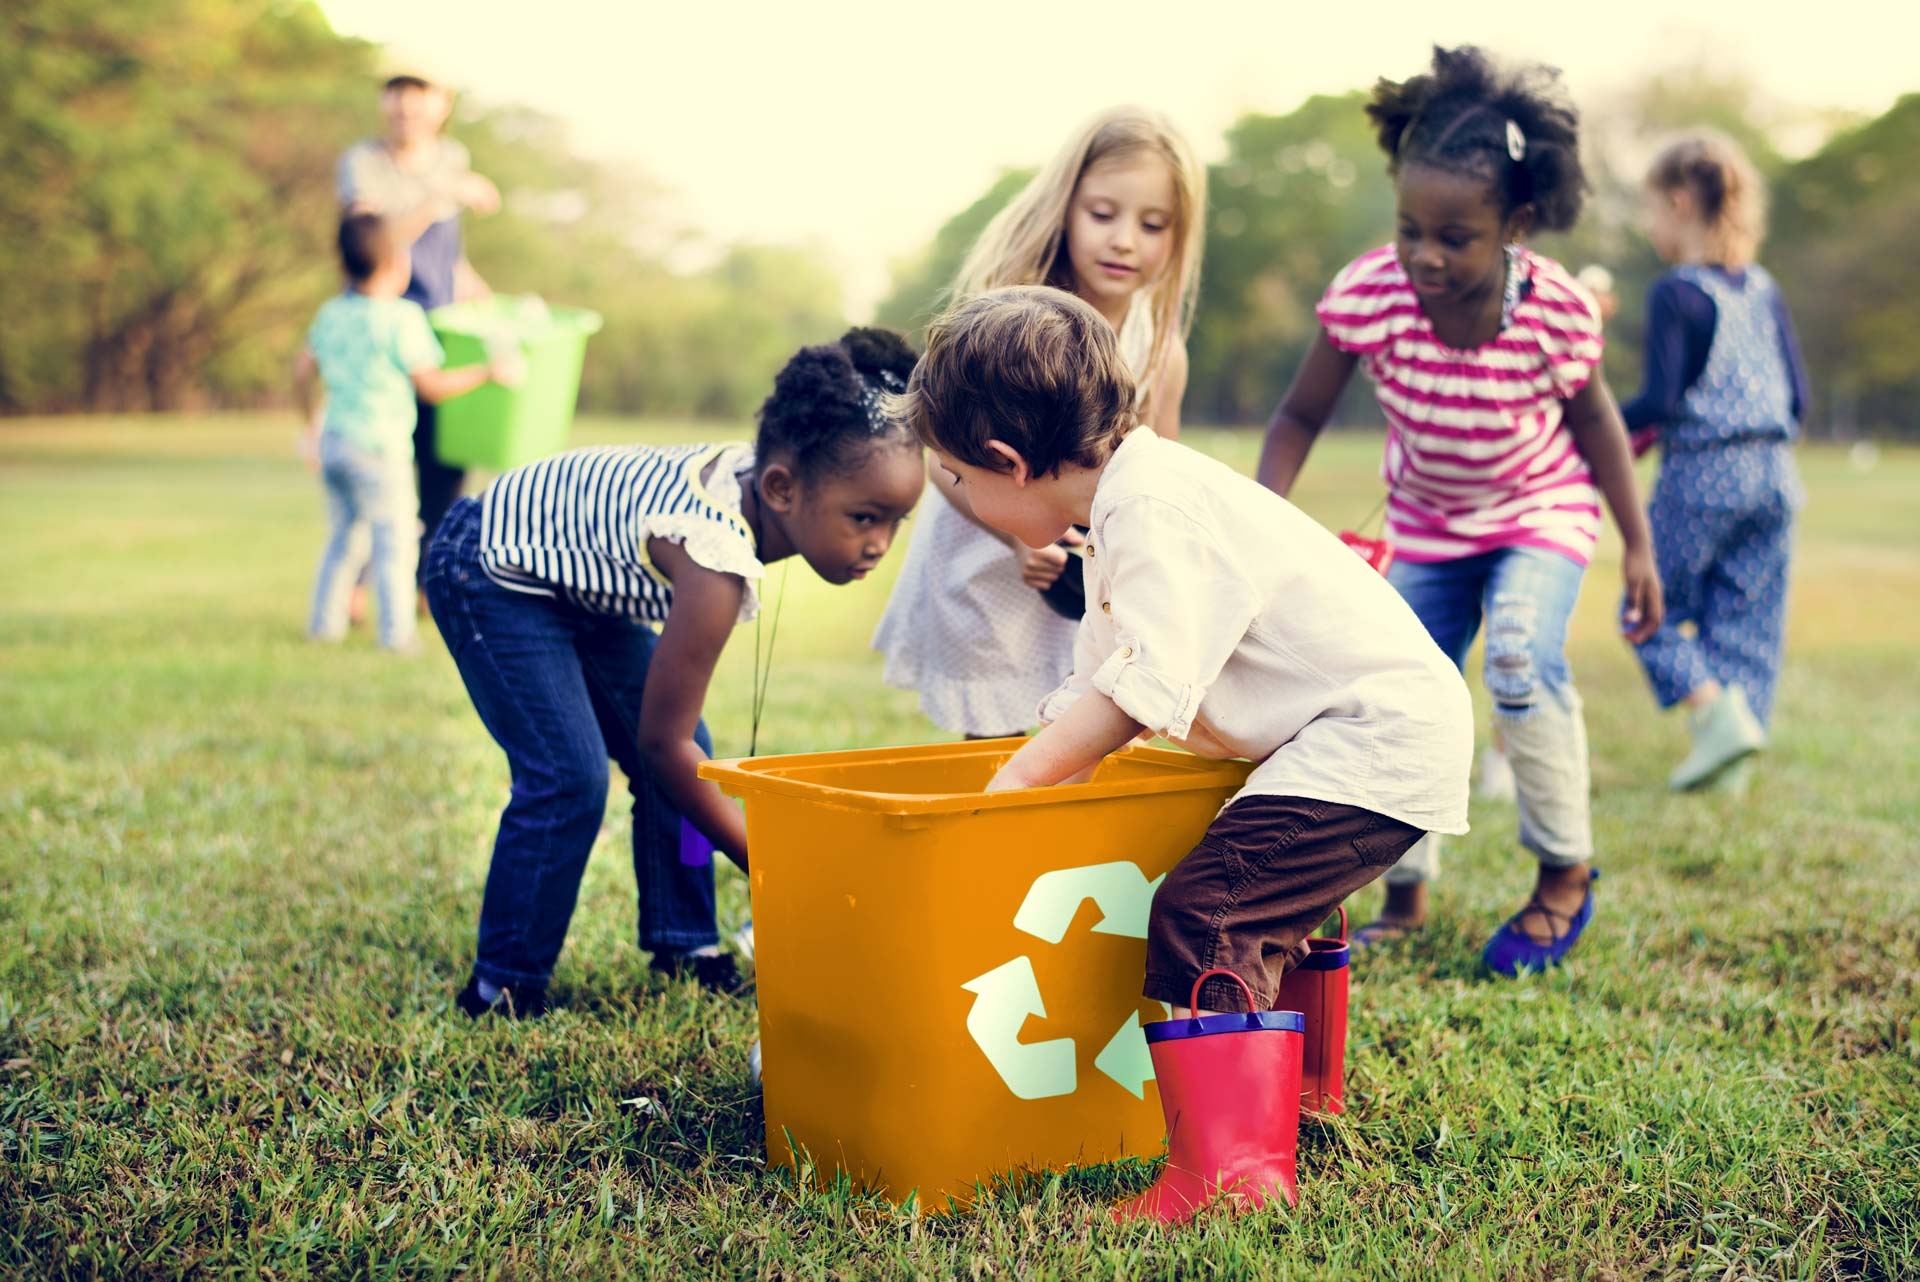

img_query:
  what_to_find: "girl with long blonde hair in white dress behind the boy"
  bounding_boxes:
[874,107,1206,739]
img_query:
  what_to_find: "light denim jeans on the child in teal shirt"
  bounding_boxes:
[307,432,420,649]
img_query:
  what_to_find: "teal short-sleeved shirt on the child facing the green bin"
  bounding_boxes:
[307,292,445,459]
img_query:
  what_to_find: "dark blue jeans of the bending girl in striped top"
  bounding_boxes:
[424,499,720,985]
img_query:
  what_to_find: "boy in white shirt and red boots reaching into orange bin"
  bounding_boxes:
[902,286,1473,1221]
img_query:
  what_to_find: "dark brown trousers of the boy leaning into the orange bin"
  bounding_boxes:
[1144,796,1421,1011]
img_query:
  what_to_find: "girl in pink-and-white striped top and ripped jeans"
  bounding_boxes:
[1260,48,1661,975]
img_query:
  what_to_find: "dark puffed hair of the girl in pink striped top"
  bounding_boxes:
[1367,44,1586,232]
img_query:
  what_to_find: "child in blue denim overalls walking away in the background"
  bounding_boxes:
[1620,132,1807,789]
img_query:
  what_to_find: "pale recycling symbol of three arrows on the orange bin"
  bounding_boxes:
[960,860,1164,1100]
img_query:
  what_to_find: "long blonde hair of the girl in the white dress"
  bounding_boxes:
[950,107,1206,416]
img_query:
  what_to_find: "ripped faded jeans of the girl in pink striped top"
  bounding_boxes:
[1386,547,1594,885]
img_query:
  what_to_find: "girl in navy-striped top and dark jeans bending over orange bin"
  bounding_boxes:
[426,330,924,1017]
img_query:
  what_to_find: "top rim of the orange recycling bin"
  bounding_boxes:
[699,739,1246,816]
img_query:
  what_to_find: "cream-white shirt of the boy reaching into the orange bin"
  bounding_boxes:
[1041,428,1473,833]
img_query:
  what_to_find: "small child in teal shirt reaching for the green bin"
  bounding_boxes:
[294,213,515,651]
